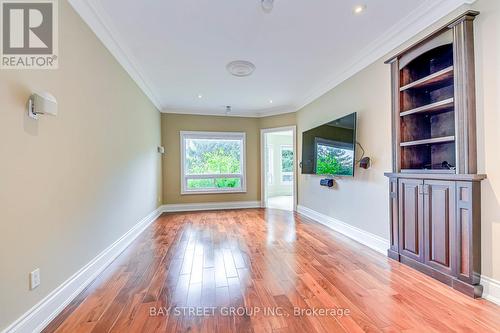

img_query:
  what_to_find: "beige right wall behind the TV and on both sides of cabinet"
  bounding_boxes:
[297,0,500,280]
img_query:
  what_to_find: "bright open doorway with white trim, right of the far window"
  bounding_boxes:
[260,126,297,211]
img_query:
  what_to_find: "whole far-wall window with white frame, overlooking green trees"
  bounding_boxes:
[181,131,246,194]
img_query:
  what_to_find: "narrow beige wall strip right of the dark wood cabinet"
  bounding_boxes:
[474,0,500,280]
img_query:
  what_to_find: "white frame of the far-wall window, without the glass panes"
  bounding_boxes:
[180,131,247,194]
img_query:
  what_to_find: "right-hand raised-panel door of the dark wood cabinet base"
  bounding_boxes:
[424,180,456,275]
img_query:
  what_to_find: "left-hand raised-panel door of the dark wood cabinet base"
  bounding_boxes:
[398,179,424,262]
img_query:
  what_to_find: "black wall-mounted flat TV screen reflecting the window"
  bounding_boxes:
[302,113,356,176]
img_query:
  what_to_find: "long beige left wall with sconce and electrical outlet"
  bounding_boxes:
[0,1,161,331]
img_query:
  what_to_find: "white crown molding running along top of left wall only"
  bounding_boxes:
[68,0,162,110]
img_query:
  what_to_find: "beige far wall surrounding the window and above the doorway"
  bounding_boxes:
[161,113,296,204]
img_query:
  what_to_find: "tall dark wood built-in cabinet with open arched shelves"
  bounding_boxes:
[386,11,486,297]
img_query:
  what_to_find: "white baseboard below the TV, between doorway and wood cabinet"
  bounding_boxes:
[297,205,390,255]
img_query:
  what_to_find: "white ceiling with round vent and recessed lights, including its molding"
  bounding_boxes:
[70,0,473,116]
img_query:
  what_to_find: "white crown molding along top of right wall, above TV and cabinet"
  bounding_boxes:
[295,0,476,111]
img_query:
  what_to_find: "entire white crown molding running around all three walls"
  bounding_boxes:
[69,0,476,118]
